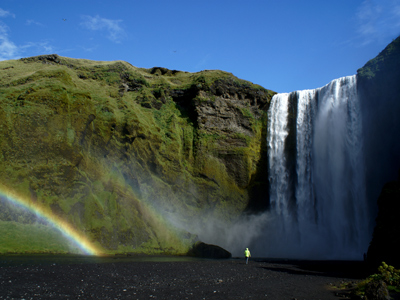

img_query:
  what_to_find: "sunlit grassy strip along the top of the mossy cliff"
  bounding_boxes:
[0,54,272,94]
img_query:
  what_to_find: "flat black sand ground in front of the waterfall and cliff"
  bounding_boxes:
[0,257,366,300]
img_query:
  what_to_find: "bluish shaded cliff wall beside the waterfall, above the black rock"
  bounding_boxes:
[357,37,400,212]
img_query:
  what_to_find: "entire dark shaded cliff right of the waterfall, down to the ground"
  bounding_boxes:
[357,37,400,267]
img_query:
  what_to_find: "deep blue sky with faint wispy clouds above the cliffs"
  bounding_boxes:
[0,0,400,92]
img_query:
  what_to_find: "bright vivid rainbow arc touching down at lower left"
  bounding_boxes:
[0,185,101,256]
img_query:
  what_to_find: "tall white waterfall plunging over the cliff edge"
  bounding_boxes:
[265,75,369,259]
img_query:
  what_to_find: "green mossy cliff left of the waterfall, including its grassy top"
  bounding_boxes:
[0,55,274,254]
